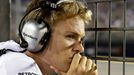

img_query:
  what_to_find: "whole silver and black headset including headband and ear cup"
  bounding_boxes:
[19,0,58,52]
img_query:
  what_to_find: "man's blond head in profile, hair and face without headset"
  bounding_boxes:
[20,0,91,72]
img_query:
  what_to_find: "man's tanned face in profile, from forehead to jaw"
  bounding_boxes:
[46,17,85,72]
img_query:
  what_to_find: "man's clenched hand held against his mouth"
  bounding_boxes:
[61,54,98,75]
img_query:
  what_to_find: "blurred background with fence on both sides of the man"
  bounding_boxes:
[0,0,134,75]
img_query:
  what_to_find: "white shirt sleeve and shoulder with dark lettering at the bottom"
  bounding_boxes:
[0,52,42,75]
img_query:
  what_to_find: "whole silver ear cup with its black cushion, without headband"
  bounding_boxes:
[19,17,50,52]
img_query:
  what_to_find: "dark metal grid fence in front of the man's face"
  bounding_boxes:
[86,0,134,75]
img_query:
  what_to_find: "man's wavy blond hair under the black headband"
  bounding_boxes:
[26,0,92,27]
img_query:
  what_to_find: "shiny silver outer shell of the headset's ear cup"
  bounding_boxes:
[22,20,49,52]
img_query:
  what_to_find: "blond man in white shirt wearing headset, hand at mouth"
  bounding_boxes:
[0,0,97,75]
